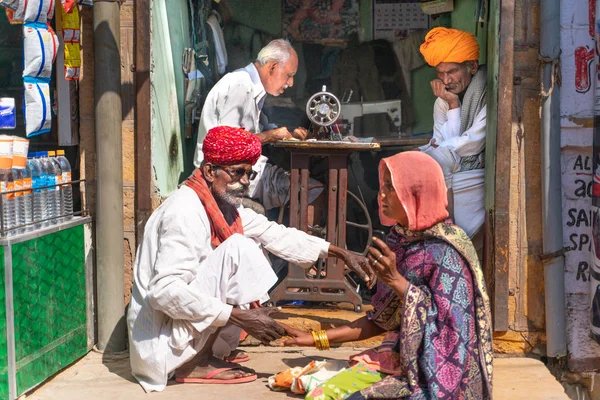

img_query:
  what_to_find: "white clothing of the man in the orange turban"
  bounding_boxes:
[421,97,486,237]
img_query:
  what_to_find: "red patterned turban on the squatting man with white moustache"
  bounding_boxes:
[202,126,262,165]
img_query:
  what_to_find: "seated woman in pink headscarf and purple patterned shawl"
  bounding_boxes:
[285,151,492,400]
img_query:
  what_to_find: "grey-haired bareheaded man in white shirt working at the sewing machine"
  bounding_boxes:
[194,39,323,215]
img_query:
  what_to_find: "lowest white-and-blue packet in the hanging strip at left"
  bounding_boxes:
[23,77,52,137]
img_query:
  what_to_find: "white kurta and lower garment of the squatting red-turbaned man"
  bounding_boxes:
[127,186,329,391]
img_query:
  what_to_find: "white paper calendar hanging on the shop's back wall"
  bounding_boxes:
[373,0,430,42]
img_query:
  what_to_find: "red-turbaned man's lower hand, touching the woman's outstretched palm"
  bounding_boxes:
[229,307,285,345]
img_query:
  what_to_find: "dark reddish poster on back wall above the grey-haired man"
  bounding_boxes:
[282,0,359,45]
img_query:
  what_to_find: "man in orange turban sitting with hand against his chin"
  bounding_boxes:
[420,27,487,237]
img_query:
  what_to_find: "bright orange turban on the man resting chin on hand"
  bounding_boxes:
[420,27,479,67]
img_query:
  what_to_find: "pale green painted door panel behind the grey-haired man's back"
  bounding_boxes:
[151,0,195,196]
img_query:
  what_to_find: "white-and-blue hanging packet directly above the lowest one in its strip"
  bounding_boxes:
[23,23,59,78]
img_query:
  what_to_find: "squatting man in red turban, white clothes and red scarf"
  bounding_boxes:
[127,126,373,392]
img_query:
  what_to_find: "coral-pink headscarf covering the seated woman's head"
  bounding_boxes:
[377,151,448,231]
